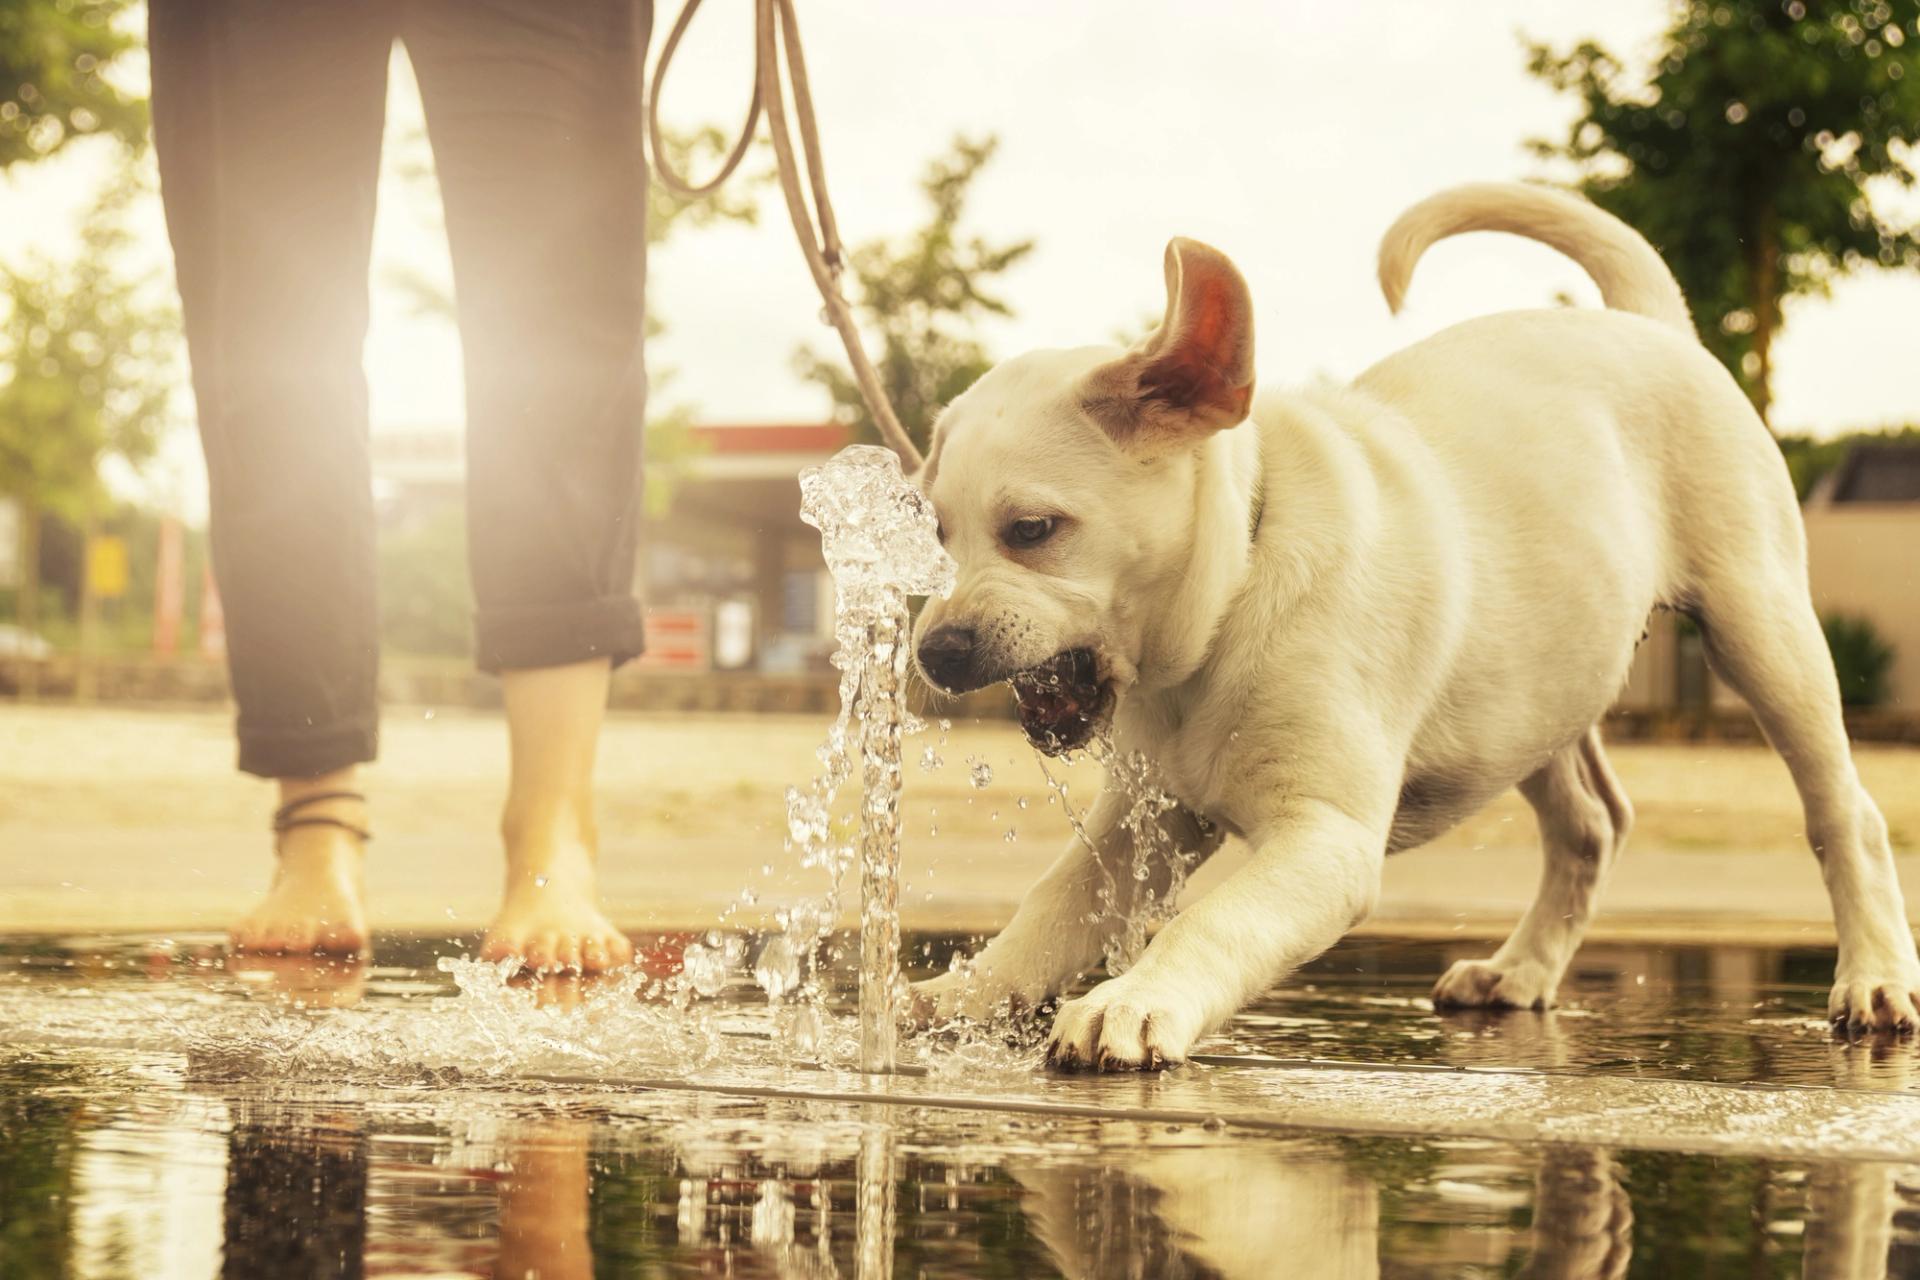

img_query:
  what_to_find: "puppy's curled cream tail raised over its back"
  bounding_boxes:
[1380,182,1693,338]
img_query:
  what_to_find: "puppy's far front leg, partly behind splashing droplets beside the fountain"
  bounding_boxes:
[914,789,1221,1021]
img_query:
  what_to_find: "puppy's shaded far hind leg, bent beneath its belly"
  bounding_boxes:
[1434,729,1634,1009]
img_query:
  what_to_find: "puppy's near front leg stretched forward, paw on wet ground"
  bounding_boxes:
[1046,800,1392,1071]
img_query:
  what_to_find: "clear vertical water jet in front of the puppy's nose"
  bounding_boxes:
[783,445,954,1071]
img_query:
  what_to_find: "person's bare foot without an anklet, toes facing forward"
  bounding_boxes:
[480,844,634,973]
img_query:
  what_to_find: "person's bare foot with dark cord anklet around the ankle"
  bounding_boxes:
[230,782,369,956]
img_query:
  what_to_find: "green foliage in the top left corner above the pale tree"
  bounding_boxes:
[0,0,146,171]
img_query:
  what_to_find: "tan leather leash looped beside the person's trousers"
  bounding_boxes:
[647,0,922,472]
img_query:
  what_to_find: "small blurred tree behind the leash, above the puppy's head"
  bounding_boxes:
[795,136,1033,449]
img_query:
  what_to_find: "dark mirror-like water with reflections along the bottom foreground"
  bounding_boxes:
[0,1069,1920,1280]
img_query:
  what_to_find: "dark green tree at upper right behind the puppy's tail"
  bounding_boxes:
[1528,0,1920,418]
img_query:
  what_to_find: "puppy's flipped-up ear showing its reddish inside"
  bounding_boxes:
[1081,238,1254,445]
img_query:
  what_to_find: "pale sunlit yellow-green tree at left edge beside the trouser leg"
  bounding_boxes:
[0,175,180,629]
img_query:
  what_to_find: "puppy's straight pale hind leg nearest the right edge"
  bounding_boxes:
[1697,579,1920,1032]
